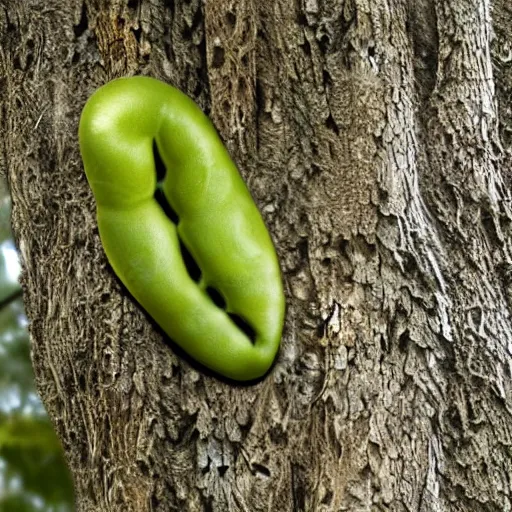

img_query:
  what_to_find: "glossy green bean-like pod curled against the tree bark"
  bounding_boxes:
[79,77,285,381]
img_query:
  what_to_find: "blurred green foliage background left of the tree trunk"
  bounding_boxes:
[0,176,73,512]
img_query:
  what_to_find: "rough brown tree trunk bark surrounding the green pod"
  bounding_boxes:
[0,0,512,512]
